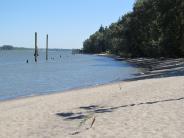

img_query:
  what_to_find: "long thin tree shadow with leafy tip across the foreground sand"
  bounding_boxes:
[56,97,184,120]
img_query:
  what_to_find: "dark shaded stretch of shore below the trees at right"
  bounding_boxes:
[122,58,184,81]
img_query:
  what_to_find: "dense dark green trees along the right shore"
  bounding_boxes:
[83,0,184,57]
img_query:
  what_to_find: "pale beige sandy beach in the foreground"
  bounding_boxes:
[0,77,184,138]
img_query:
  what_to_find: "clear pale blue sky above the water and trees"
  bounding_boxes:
[0,0,135,48]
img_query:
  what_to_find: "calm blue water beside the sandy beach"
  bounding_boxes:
[0,50,139,100]
